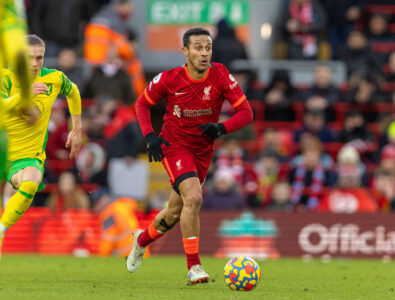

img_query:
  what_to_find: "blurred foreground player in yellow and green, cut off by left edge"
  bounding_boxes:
[0,0,32,189]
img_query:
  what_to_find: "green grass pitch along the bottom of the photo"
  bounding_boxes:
[0,255,395,300]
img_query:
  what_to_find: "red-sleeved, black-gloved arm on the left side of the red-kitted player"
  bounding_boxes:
[135,74,170,162]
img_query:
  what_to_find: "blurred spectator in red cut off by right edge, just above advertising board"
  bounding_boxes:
[372,168,395,211]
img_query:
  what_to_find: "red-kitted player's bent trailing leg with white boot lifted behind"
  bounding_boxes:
[126,191,183,273]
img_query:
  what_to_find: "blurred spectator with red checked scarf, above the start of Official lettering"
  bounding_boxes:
[289,139,332,210]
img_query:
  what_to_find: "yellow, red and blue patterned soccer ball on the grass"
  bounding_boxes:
[224,256,261,291]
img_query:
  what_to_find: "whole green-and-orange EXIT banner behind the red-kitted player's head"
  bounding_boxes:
[146,0,250,51]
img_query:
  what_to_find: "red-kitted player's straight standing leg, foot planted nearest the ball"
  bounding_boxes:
[179,177,210,284]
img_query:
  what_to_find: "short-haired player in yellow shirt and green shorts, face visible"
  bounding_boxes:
[0,35,81,258]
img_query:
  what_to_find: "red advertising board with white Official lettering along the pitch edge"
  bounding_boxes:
[3,208,395,258]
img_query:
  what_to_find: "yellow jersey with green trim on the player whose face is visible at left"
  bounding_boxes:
[0,68,81,161]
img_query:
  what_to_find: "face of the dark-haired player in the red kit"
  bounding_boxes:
[183,35,213,73]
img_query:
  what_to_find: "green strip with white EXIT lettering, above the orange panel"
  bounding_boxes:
[148,0,249,25]
